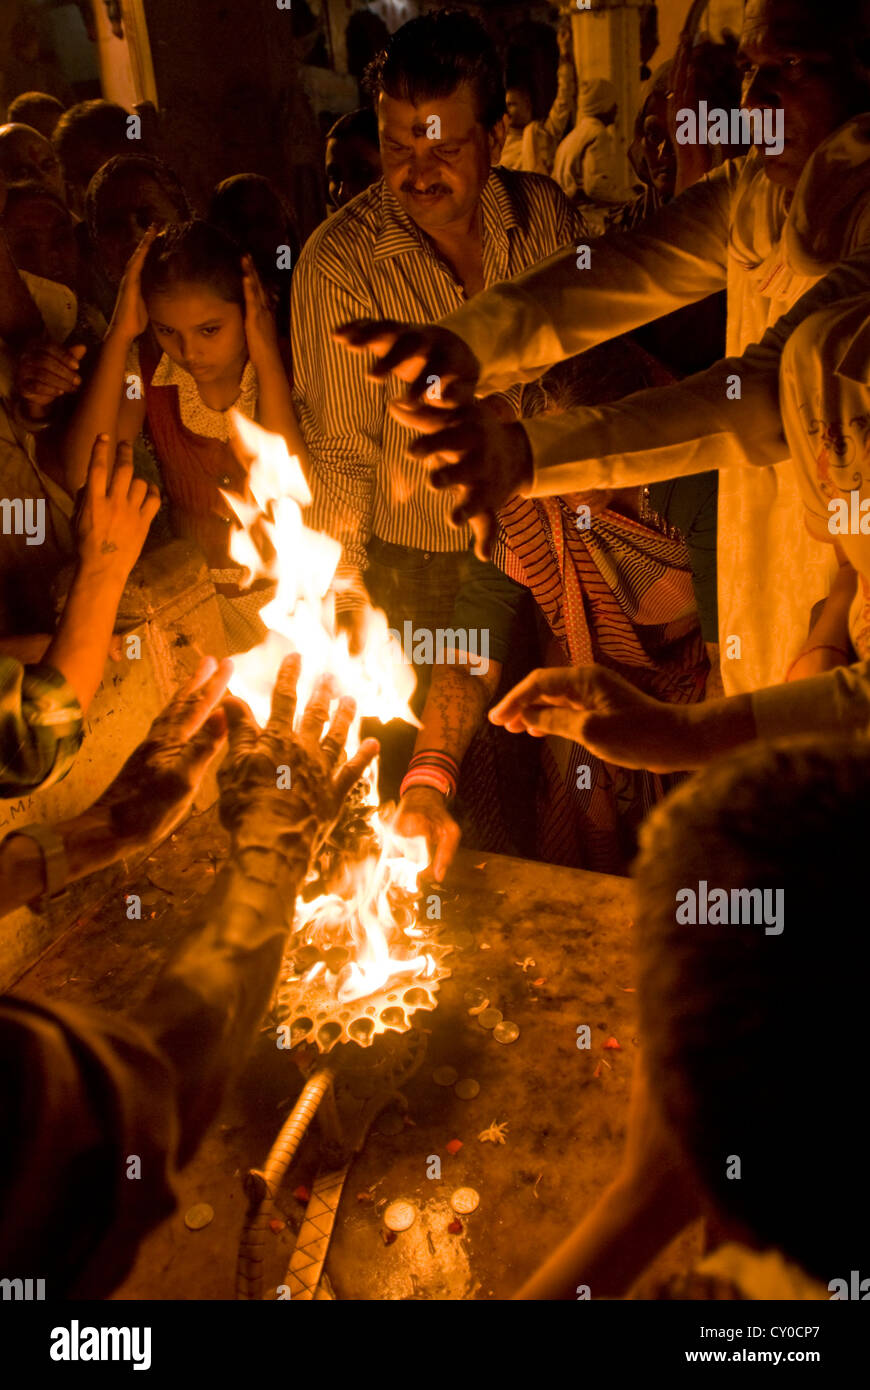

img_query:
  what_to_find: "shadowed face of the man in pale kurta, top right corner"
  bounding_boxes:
[738,0,863,189]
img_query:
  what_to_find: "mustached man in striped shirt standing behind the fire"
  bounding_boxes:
[292,11,584,800]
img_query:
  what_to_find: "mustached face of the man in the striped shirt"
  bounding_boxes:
[378,82,504,231]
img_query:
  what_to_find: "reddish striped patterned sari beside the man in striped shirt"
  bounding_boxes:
[493,495,709,873]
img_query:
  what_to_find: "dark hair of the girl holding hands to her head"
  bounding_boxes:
[142,220,245,310]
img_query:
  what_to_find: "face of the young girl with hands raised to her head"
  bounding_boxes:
[147,285,247,385]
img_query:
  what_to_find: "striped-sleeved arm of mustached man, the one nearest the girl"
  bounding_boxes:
[292,247,385,609]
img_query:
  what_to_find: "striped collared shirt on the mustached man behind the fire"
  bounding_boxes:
[292,168,584,592]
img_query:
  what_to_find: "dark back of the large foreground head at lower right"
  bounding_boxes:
[635,738,870,1298]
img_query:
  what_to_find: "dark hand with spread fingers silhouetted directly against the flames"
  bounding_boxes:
[218,653,378,883]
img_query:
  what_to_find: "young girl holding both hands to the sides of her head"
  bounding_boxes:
[64,221,304,651]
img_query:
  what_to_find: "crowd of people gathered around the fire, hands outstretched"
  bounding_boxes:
[0,0,870,1298]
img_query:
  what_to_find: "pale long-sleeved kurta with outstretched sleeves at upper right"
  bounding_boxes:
[442,115,870,694]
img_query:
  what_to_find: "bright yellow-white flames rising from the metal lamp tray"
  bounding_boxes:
[224,411,448,1045]
